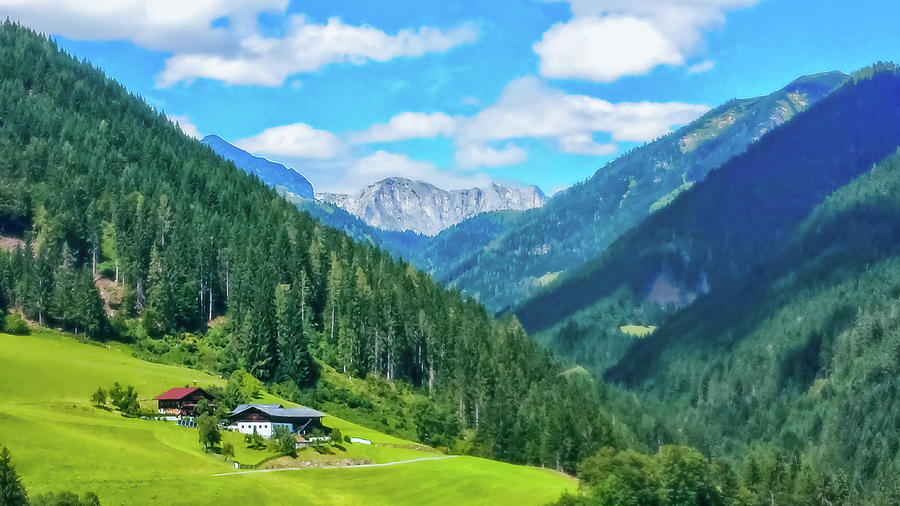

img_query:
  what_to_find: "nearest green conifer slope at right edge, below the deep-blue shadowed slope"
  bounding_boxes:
[609,147,900,490]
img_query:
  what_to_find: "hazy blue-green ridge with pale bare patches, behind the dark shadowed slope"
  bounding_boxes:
[438,72,846,310]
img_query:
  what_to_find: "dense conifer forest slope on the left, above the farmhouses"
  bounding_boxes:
[0,21,622,470]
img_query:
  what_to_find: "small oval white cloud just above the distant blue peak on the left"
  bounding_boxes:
[235,123,344,160]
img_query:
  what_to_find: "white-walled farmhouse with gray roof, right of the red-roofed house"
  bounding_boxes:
[228,404,325,438]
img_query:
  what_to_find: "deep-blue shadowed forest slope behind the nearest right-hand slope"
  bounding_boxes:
[514,65,900,368]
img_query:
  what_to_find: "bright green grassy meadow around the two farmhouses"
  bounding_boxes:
[0,331,576,504]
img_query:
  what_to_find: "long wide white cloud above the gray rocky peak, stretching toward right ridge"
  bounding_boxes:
[348,77,709,170]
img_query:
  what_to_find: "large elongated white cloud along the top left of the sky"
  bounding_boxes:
[0,0,479,87]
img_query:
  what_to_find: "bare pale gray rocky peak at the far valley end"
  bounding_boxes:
[316,177,547,235]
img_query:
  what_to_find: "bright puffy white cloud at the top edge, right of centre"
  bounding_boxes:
[534,0,759,82]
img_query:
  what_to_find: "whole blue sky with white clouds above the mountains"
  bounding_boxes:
[0,0,900,194]
